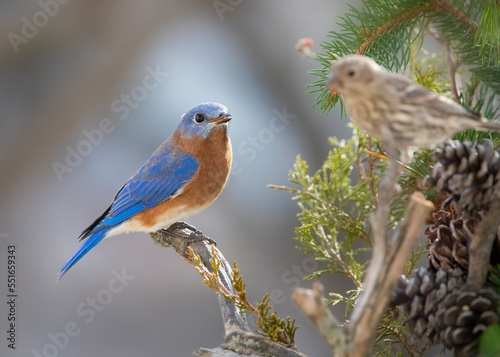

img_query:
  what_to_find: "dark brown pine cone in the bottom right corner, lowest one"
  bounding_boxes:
[435,288,498,357]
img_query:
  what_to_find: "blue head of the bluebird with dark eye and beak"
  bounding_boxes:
[177,102,232,138]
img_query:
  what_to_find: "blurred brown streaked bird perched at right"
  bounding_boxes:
[326,55,500,158]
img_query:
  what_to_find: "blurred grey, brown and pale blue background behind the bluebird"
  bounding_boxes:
[0,0,364,357]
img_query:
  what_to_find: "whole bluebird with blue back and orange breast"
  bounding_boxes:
[58,103,233,278]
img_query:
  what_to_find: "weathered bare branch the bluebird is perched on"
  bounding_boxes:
[150,222,306,357]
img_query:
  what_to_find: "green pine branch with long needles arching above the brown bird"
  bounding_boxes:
[310,0,500,114]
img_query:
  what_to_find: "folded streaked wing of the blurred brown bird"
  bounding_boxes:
[390,76,481,120]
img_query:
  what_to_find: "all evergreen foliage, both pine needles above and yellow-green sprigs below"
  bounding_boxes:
[271,0,500,356]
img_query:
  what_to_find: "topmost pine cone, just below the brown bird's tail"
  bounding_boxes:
[427,140,500,217]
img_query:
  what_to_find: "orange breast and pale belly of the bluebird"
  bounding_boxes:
[134,125,233,231]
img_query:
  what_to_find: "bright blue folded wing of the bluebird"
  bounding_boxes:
[80,145,198,239]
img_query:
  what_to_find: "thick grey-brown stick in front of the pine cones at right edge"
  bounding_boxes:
[467,203,500,290]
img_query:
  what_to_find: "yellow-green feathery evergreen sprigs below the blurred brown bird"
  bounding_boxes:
[270,124,429,356]
